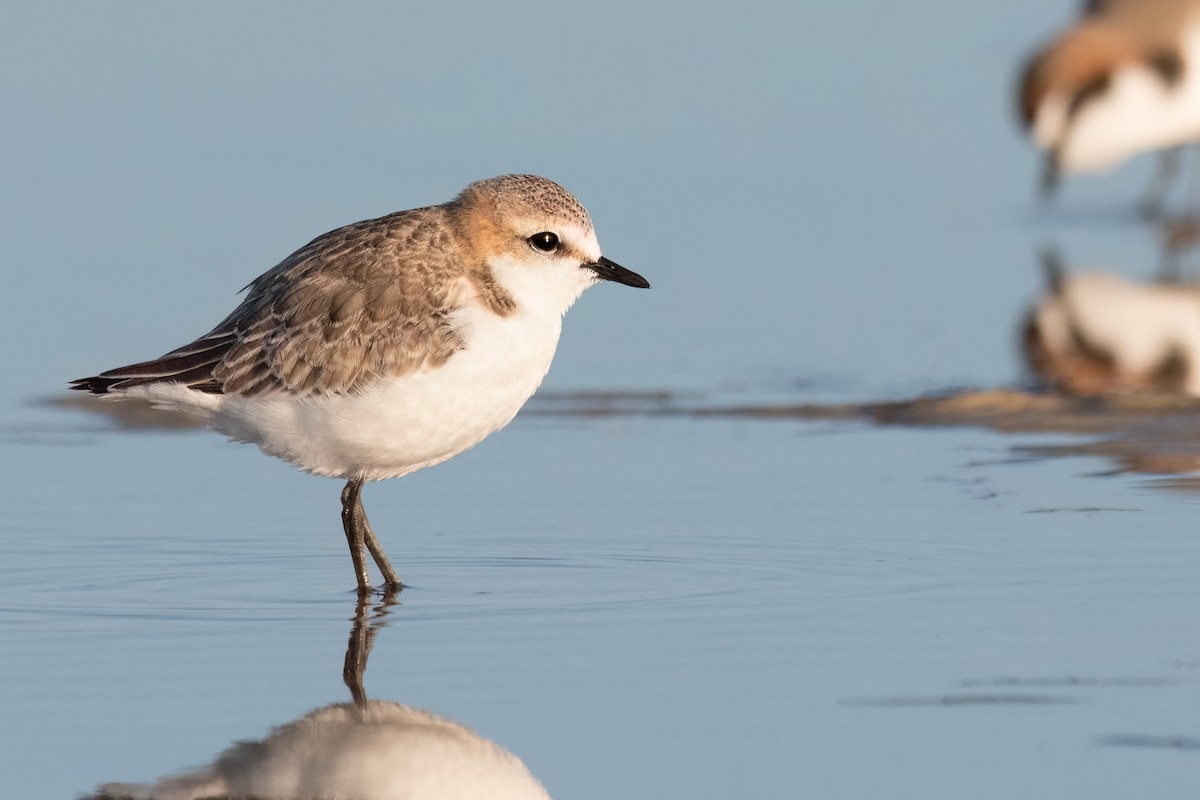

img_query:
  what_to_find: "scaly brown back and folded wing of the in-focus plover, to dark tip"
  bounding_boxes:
[72,206,463,396]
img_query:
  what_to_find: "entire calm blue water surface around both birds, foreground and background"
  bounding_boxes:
[7,0,1200,800]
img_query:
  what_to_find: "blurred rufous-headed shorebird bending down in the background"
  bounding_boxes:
[1018,0,1200,211]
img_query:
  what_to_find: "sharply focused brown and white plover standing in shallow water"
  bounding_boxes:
[72,175,649,594]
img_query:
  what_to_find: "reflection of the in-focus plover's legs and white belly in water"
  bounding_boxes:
[90,594,550,800]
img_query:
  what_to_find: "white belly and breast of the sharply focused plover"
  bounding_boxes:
[130,307,562,481]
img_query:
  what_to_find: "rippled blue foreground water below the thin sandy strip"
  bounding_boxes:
[7,407,1200,798]
